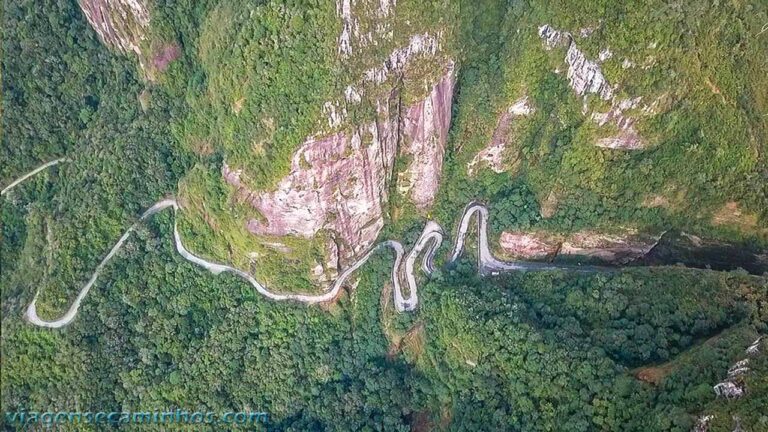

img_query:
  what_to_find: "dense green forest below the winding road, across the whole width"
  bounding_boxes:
[2,213,768,431]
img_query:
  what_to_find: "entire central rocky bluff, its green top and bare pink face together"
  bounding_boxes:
[173,0,455,290]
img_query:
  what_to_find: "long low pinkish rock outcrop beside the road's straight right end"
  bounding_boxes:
[499,230,658,264]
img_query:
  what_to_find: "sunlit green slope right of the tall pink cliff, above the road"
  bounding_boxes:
[438,1,768,244]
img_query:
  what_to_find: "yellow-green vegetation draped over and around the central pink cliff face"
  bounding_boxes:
[167,0,454,292]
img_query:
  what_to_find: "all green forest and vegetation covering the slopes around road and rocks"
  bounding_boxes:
[0,0,768,432]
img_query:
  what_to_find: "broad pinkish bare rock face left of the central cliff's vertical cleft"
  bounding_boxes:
[222,115,397,258]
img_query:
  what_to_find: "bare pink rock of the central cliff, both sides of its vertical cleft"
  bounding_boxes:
[222,67,454,259]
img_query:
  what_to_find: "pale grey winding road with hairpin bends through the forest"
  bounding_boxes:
[4,160,764,328]
